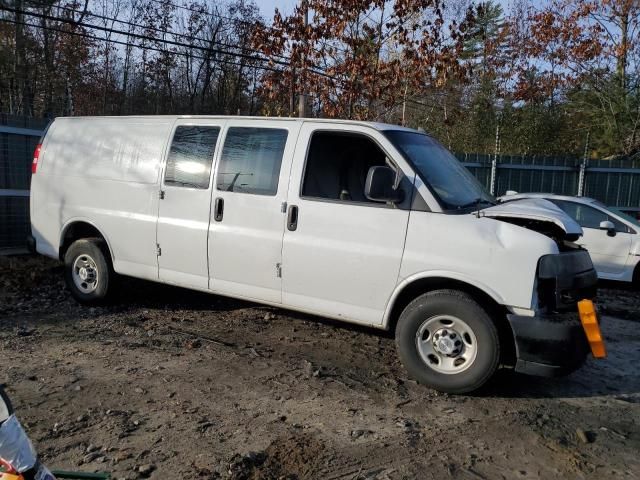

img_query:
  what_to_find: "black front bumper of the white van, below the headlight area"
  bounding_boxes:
[507,312,590,377]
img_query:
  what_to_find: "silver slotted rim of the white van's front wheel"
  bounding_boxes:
[416,315,478,375]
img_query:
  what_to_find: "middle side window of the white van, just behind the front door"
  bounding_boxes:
[216,127,288,195]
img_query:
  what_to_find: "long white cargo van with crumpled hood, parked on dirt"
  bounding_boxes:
[31,116,596,392]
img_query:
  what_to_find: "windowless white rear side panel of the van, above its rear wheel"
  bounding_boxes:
[32,117,174,279]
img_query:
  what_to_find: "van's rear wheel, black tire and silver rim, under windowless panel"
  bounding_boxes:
[64,238,115,304]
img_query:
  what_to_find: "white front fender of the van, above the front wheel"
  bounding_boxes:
[400,211,557,309]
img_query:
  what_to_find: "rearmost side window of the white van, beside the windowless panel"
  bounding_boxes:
[164,125,220,189]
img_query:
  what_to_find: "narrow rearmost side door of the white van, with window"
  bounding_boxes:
[156,119,224,289]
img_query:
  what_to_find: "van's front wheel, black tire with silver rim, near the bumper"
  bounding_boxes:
[396,290,500,393]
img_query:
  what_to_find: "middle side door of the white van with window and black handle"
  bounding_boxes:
[209,120,300,303]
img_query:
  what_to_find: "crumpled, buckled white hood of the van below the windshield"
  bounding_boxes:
[479,198,582,241]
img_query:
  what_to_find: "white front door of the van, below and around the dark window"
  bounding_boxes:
[282,123,413,325]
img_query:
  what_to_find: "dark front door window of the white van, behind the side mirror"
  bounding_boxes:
[301,132,386,203]
